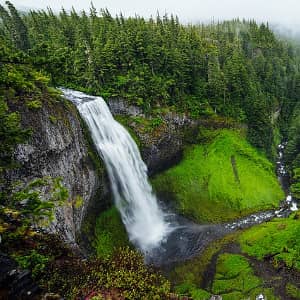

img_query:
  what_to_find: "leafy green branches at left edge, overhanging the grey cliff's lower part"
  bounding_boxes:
[0,177,68,240]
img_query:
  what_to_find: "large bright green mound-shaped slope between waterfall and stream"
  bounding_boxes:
[152,130,284,222]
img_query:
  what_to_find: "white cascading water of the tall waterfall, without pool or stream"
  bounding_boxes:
[61,89,171,252]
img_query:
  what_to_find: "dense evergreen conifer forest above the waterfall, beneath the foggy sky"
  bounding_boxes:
[0,2,300,155]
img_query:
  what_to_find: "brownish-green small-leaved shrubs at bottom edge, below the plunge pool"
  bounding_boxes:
[40,248,170,300]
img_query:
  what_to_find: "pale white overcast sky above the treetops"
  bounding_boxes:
[0,0,300,32]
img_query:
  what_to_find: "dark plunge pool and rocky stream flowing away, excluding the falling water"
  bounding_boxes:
[145,142,298,267]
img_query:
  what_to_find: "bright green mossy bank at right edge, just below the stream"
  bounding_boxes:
[239,215,300,271]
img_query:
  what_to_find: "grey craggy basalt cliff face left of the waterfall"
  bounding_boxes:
[6,99,109,243]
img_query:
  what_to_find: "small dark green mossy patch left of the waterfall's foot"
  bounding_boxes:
[93,207,129,259]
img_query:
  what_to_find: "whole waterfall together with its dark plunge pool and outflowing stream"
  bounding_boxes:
[61,89,298,267]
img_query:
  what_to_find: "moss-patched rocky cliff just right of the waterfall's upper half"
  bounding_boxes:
[109,99,198,176]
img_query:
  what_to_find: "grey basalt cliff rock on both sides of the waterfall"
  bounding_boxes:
[5,99,196,244]
